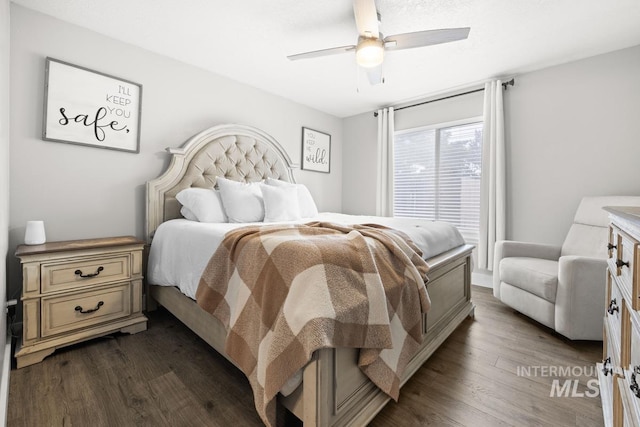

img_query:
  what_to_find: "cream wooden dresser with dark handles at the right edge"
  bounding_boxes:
[598,207,640,426]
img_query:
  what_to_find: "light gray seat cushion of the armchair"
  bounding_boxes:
[499,257,558,303]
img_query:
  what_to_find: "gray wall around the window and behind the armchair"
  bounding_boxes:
[342,46,640,244]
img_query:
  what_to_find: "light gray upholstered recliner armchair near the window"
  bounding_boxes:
[493,196,640,340]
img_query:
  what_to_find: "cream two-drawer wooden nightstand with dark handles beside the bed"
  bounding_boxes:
[15,237,147,368]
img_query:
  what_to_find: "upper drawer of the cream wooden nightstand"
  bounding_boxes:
[41,253,131,293]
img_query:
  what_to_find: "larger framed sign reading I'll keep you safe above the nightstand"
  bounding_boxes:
[42,58,142,153]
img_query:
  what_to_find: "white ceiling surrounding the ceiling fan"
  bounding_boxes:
[13,0,640,117]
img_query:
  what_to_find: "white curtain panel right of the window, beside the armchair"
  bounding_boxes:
[478,80,506,270]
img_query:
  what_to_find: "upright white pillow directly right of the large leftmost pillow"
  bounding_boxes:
[218,177,264,222]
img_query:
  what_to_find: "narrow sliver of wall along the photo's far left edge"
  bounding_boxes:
[0,0,9,398]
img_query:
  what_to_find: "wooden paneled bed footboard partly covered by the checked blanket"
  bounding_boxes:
[279,246,475,426]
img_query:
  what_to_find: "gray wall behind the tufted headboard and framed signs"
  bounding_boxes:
[7,4,342,297]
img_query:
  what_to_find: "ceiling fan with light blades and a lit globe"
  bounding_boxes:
[287,0,471,84]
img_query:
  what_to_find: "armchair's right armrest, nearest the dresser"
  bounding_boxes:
[555,255,607,341]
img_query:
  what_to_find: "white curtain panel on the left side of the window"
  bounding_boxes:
[376,107,394,216]
